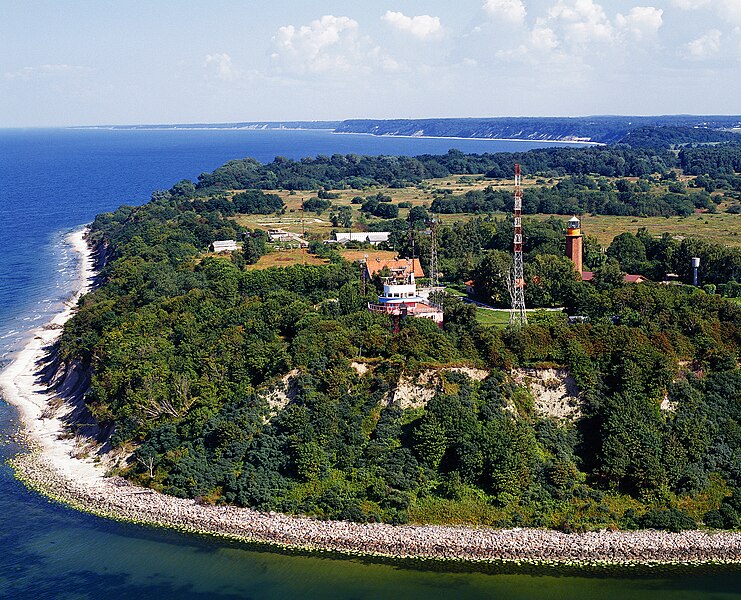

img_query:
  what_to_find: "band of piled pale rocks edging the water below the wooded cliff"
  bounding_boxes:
[10,453,741,565]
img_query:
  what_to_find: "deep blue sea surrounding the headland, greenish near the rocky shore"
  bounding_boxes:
[0,129,741,600]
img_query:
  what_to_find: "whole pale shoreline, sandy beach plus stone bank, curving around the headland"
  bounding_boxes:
[0,230,741,572]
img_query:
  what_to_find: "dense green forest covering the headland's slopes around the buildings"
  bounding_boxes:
[60,143,741,531]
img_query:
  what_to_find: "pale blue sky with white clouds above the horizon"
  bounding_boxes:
[0,0,741,127]
